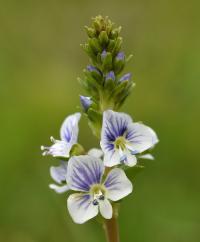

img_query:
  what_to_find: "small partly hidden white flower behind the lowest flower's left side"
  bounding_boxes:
[49,161,69,193]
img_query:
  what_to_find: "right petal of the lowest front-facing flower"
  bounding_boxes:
[104,168,133,201]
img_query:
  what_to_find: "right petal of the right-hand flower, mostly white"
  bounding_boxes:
[126,123,158,154]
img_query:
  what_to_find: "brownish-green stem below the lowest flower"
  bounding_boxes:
[104,216,120,242]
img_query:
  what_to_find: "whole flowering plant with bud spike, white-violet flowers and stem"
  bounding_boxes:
[41,16,158,242]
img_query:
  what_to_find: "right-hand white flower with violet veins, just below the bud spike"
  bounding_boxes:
[100,110,158,167]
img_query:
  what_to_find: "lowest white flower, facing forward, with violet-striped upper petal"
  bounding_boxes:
[67,155,132,224]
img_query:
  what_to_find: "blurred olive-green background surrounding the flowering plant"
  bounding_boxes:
[0,0,200,242]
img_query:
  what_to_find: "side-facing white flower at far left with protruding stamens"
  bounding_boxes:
[41,113,81,158]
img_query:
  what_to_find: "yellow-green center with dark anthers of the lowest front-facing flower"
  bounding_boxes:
[90,184,106,205]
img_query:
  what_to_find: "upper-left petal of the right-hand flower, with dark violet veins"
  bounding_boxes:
[101,110,132,153]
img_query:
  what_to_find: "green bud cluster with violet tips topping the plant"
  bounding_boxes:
[79,16,134,138]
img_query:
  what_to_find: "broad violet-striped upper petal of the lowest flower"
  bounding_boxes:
[67,155,104,191]
